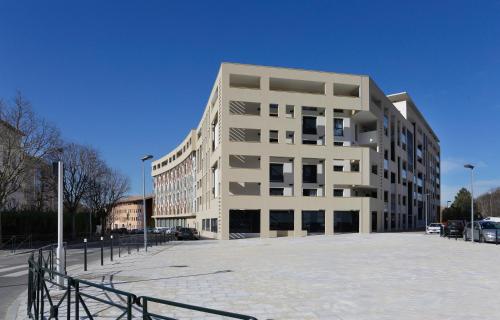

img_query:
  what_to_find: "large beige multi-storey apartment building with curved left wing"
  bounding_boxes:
[152,63,440,239]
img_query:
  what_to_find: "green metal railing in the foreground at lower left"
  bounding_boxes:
[27,245,256,320]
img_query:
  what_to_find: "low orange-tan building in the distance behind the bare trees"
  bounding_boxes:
[108,195,154,230]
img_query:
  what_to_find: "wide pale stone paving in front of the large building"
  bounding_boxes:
[13,233,500,320]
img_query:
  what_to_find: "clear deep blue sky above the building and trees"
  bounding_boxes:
[0,0,500,202]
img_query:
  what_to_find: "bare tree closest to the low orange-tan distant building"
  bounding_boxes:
[83,167,130,234]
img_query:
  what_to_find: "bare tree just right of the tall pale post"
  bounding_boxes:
[60,143,104,238]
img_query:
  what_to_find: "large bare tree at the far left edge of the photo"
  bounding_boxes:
[0,92,60,242]
